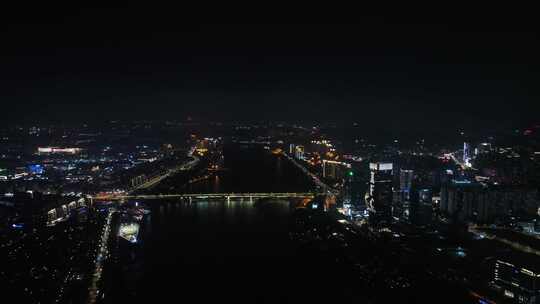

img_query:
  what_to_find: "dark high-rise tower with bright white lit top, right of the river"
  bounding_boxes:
[366,163,393,225]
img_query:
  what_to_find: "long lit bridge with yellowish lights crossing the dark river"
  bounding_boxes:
[88,192,318,202]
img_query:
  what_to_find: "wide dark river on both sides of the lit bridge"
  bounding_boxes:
[101,149,368,303]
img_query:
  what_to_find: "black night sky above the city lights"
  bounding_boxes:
[0,7,540,129]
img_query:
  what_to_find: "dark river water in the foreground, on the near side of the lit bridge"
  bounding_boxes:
[138,201,320,302]
